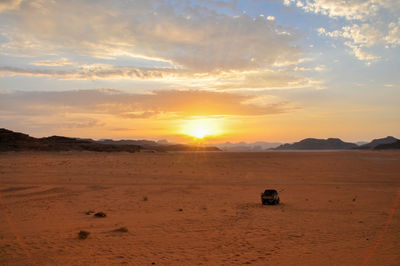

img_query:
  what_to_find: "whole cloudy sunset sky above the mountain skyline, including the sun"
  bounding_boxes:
[0,0,400,143]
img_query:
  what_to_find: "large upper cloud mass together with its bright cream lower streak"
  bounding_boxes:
[0,0,318,94]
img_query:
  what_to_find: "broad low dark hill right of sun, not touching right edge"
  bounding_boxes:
[274,138,358,150]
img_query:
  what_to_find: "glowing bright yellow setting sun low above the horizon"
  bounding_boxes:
[182,118,221,140]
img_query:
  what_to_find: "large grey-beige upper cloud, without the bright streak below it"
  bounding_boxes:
[0,0,302,72]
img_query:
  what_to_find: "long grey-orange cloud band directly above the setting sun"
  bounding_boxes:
[0,89,296,139]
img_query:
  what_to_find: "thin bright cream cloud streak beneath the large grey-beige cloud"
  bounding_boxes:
[0,61,321,91]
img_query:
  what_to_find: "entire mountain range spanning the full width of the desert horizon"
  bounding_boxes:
[0,128,400,152]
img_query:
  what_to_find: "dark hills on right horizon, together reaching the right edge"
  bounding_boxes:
[273,137,399,150]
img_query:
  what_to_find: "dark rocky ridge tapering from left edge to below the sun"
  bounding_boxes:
[0,128,220,152]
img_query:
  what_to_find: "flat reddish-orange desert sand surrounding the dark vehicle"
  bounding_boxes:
[0,151,400,265]
